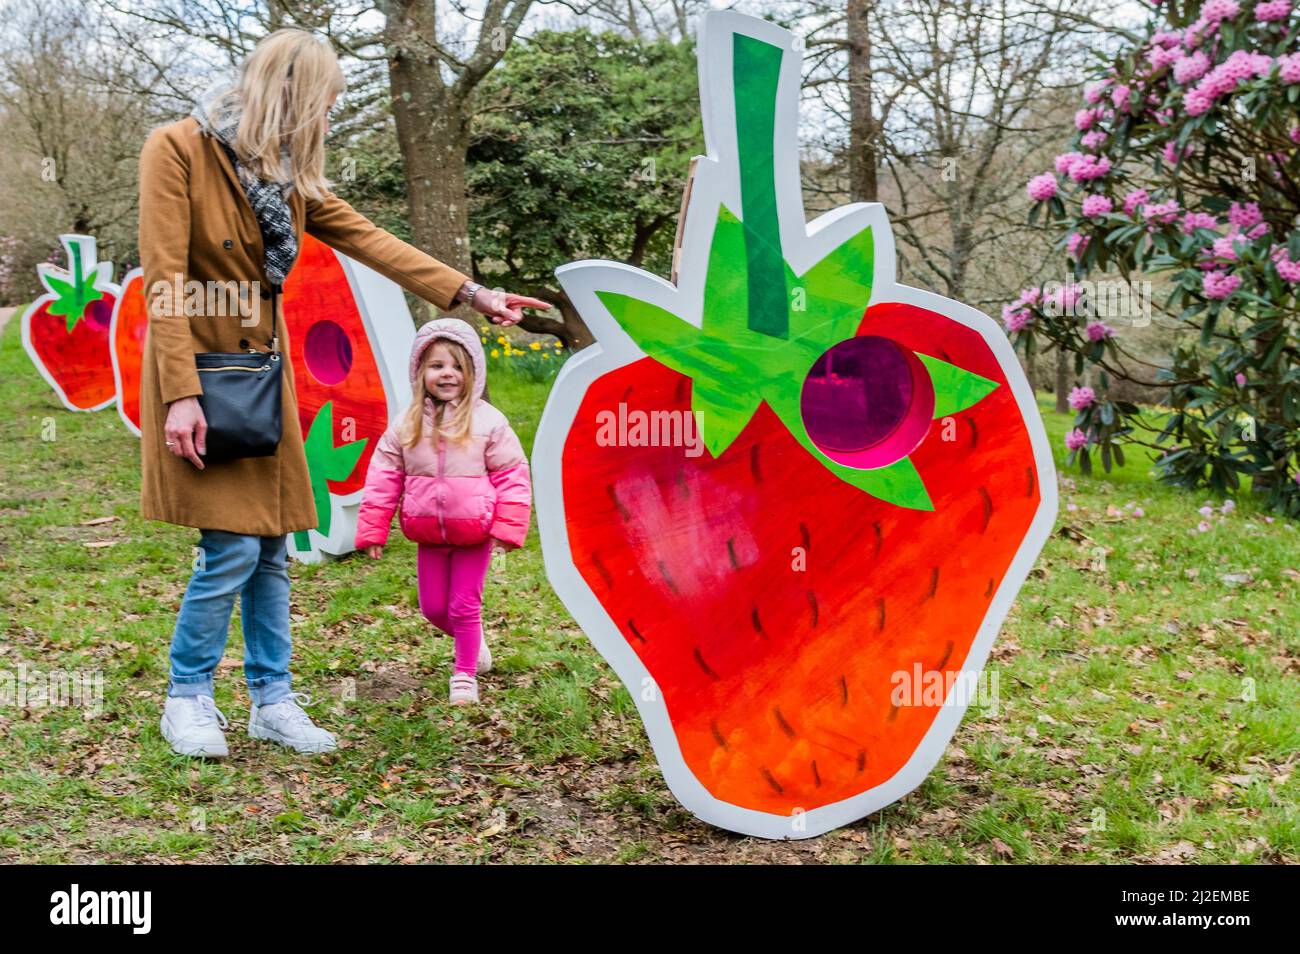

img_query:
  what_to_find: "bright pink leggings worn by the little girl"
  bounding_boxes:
[416,539,491,675]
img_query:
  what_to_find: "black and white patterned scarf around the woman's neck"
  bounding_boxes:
[191,81,298,285]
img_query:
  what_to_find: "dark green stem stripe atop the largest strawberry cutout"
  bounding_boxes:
[732,34,789,338]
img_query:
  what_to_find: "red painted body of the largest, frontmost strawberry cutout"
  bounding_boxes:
[563,304,1040,816]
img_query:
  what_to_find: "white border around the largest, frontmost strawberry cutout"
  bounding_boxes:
[532,10,1058,838]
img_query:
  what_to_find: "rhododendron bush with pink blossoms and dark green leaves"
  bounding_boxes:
[1019,0,1300,516]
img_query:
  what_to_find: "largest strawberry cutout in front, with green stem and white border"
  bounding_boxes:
[533,12,1056,837]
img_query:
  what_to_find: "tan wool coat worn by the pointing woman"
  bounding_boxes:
[139,117,467,537]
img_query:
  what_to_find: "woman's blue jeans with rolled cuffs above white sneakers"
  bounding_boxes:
[168,530,294,706]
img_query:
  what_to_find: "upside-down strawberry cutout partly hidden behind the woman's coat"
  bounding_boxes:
[283,233,415,561]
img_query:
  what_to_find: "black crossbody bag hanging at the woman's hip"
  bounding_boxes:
[194,285,285,463]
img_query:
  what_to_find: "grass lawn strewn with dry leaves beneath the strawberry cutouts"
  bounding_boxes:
[0,320,1300,863]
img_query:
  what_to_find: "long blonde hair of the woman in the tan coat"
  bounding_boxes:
[235,27,347,201]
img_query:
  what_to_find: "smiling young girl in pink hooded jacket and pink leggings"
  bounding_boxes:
[356,318,532,706]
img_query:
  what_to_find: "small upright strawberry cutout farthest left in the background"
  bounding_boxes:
[22,235,118,411]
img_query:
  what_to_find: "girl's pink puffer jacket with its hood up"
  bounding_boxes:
[356,318,532,550]
